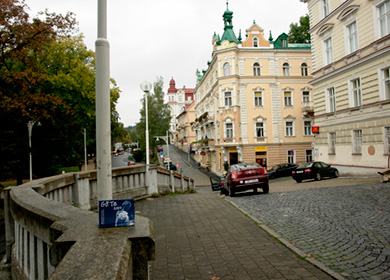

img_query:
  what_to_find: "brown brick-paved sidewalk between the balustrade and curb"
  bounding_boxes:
[135,186,333,280]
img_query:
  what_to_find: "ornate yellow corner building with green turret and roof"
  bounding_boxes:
[192,6,314,172]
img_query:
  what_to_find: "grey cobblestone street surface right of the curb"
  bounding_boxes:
[226,180,390,279]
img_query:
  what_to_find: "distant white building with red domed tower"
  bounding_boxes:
[168,77,194,140]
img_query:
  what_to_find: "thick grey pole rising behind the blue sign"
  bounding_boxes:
[95,0,112,200]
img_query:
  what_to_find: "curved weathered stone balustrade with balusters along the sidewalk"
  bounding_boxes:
[4,165,195,279]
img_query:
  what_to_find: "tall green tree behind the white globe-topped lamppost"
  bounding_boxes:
[136,77,171,162]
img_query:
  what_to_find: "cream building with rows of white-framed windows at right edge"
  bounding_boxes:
[301,0,390,169]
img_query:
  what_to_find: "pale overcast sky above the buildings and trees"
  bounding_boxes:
[26,0,308,126]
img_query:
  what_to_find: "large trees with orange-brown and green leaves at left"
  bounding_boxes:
[0,0,124,184]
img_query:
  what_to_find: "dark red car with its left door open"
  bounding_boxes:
[222,162,269,196]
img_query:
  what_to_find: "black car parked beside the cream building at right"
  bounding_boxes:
[292,161,339,183]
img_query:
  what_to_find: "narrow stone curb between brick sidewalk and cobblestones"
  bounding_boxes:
[225,196,346,280]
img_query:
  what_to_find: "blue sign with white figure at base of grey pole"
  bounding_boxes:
[99,199,135,227]
